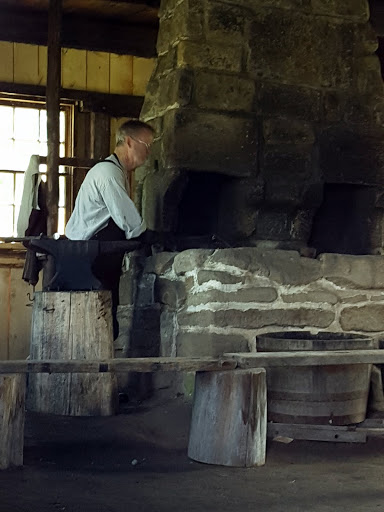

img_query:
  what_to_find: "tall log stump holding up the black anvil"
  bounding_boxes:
[27,290,117,416]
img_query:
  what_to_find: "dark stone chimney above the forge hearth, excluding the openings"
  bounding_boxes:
[137,0,384,252]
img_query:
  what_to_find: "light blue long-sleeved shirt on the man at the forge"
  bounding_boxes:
[65,155,146,240]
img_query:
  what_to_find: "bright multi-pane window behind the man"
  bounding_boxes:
[0,100,72,236]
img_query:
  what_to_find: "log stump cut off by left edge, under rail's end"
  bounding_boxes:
[0,375,25,469]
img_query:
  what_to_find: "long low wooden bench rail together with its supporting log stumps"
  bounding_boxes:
[0,350,384,469]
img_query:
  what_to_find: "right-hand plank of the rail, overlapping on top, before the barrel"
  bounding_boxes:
[223,350,384,369]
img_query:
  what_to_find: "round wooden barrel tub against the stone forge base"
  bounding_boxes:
[256,331,377,425]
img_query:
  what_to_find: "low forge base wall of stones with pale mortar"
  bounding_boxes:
[119,248,384,357]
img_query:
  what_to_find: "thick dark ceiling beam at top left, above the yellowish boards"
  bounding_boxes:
[0,8,158,58]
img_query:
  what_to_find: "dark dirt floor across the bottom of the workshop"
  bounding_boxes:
[0,399,384,512]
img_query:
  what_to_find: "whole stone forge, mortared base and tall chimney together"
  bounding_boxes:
[117,0,384,396]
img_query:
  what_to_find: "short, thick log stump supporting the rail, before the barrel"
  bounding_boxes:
[188,368,267,467]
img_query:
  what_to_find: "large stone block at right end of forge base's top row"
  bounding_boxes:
[318,254,384,289]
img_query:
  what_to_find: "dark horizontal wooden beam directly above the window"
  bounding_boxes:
[0,82,144,117]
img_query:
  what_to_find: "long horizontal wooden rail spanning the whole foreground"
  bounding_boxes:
[0,350,384,374]
